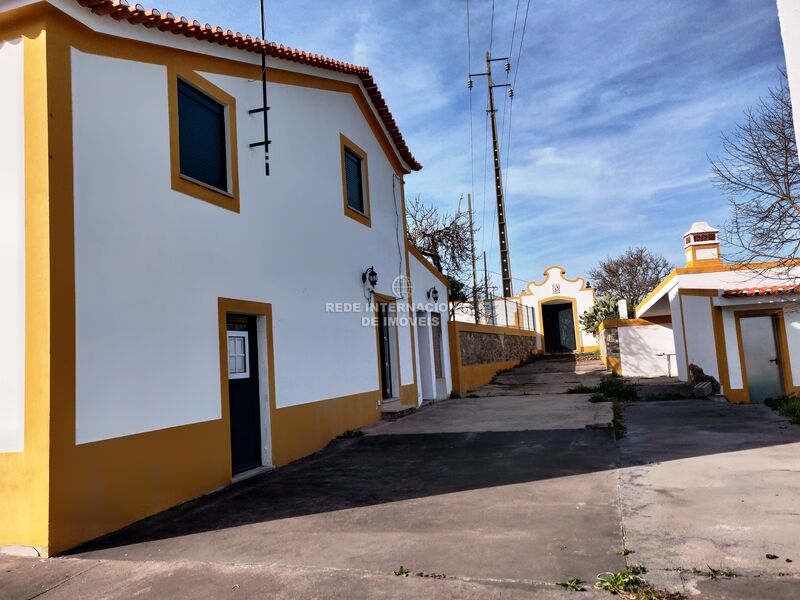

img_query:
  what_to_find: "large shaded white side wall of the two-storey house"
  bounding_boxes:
[72,49,414,443]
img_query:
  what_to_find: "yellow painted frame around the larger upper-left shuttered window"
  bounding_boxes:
[167,63,239,213]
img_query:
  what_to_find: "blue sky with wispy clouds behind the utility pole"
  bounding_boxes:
[159,0,784,291]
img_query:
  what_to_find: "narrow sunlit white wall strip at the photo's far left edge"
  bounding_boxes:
[0,39,25,452]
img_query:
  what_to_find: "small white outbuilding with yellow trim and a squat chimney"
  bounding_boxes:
[600,222,800,403]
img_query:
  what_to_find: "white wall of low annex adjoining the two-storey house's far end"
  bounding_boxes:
[408,254,453,402]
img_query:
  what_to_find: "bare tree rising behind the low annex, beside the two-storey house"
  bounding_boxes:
[406,196,482,312]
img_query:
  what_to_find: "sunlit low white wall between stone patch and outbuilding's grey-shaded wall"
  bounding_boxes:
[617,324,678,377]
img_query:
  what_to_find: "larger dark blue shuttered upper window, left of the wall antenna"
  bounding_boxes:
[178,79,228,191]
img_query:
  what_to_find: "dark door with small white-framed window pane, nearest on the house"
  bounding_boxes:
[227,314,262,475]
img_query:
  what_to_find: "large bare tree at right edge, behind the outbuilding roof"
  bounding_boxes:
[709,71,800,276]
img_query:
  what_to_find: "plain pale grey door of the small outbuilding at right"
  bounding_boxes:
[739,316,784,402]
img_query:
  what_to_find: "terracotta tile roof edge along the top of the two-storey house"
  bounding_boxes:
[76,0,422,171]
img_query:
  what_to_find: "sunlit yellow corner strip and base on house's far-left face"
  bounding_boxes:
[0,21,53,555]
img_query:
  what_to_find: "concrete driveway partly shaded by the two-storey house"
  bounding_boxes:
[0,360,800,599]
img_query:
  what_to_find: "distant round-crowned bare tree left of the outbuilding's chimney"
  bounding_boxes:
[589,247,673,314]
